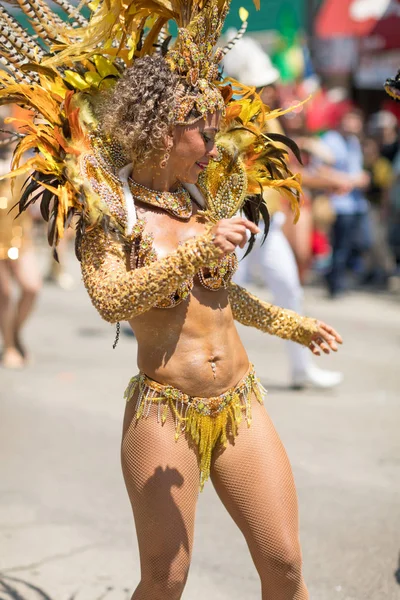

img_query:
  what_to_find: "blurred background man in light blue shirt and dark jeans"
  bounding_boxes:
[322,109,372,298]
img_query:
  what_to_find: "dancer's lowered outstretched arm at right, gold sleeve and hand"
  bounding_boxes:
[228,283,342,355]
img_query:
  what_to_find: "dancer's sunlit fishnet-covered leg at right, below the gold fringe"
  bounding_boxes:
[211,401,309,600]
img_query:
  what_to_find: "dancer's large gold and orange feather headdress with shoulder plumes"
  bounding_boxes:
[0,0,300,247]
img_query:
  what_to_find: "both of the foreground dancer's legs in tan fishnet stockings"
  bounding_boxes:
[122,386,309,600]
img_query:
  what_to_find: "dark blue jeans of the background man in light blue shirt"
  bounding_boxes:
[326,213,372,295]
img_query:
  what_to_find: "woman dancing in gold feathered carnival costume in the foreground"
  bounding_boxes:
[0,0,340,600]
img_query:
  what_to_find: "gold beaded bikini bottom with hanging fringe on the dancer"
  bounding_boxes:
[124,365,266,489]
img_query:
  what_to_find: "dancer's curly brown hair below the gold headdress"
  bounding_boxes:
[98,55,180,163]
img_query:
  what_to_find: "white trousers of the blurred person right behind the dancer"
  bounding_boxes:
[234,212,311,374]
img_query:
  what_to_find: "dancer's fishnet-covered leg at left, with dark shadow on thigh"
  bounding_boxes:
[122,398,200,600]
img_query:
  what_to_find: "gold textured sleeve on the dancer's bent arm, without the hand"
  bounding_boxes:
[81,226,222,323]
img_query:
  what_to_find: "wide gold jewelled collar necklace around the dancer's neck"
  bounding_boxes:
[128,178,192,221]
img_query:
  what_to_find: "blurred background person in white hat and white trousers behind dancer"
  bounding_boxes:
[224,31,342,389]
